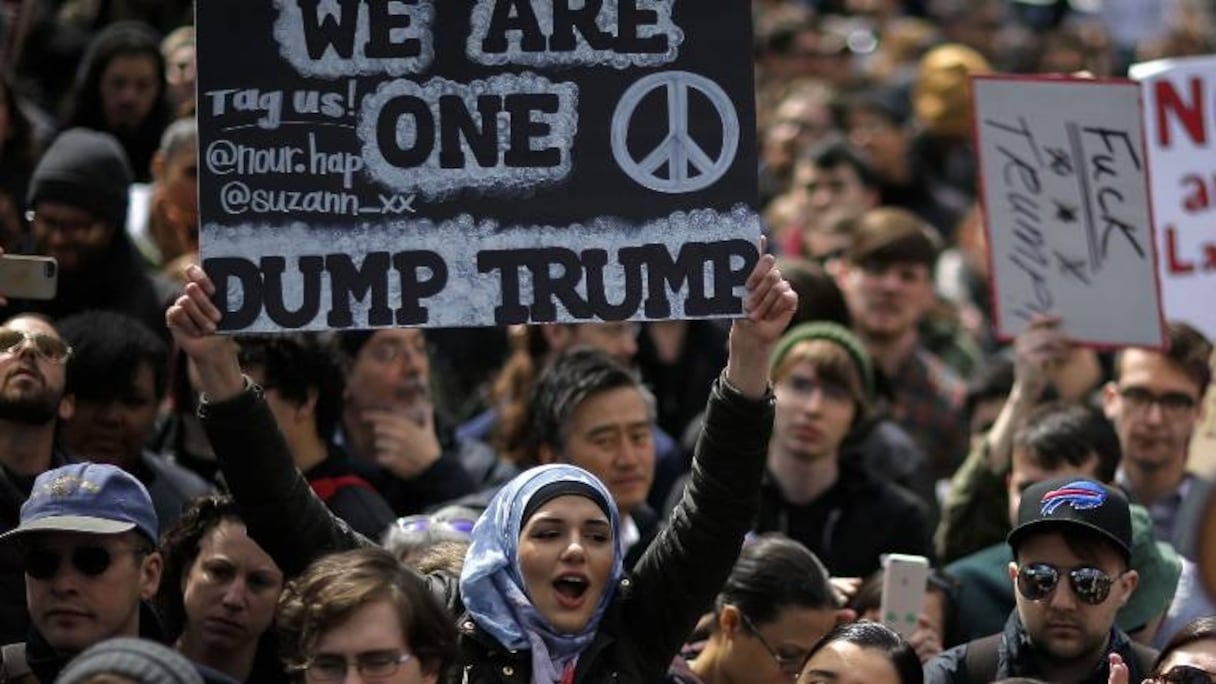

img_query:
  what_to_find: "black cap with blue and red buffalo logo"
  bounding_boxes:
[1007,475,1132,560]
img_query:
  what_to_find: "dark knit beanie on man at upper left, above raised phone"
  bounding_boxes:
[26,128,133,230]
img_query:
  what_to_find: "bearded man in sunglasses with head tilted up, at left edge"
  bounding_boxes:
[0,314,74,644]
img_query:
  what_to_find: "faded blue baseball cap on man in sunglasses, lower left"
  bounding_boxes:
[0,462,159,544]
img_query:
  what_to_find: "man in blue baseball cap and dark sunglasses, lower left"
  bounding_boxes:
[0,462,163,683]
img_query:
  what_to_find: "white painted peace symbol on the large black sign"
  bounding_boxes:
[612,71,739,195]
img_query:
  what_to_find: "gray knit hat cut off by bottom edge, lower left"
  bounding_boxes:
[55,638,203,684]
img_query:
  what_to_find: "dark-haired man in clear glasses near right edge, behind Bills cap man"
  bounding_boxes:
[1103,323,1212,560]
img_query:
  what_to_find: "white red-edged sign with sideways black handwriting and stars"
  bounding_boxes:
[973,77,1165,347]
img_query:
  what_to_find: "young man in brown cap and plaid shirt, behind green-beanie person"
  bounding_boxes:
[839,207,967,478]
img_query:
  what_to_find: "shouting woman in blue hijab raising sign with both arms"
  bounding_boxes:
[167,254,798,684]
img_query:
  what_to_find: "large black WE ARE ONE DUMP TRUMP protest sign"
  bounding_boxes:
[197,0,760,330]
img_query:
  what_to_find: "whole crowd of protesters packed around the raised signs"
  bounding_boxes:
[0,0,1216,684]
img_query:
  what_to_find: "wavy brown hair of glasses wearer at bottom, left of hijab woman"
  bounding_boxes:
[278,549,456,678]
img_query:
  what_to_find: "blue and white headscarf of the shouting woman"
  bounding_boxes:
[460,464,624,684]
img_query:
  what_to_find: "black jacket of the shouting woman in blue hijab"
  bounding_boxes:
[202,381,773,684]
